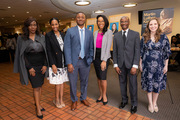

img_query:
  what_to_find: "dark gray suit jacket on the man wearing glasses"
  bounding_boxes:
[113,29,140,69]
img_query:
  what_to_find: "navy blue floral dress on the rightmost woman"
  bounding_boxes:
[141,34,171,93]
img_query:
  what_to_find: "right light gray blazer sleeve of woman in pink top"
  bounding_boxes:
[103,30,113,61]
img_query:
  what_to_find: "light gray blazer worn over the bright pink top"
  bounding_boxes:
[94,29,113,61]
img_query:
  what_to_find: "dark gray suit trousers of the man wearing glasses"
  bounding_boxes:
[119,64,137,106]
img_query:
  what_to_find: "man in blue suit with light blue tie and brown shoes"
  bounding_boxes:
[64,12,94,110]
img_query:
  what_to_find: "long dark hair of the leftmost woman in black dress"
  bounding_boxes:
[22,17,40,40]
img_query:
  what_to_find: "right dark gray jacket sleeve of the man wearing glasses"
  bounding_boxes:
[133,33,140,65]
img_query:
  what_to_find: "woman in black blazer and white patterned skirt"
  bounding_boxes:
[45,18,68,108]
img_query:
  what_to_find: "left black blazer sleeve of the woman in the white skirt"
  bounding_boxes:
[45,34,55,66]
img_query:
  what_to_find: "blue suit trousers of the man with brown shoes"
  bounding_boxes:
[68,59,90,102]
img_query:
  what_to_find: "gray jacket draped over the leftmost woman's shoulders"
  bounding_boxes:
[14,35,48,85]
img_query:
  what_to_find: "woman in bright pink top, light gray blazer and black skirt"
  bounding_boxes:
[93,15,113,105]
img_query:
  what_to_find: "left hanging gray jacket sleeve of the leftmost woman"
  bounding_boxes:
[13,36,21,73]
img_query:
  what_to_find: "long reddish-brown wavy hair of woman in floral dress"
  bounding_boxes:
[143,18,162,43]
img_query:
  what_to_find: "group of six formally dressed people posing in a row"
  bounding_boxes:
[14,12,171,119]
